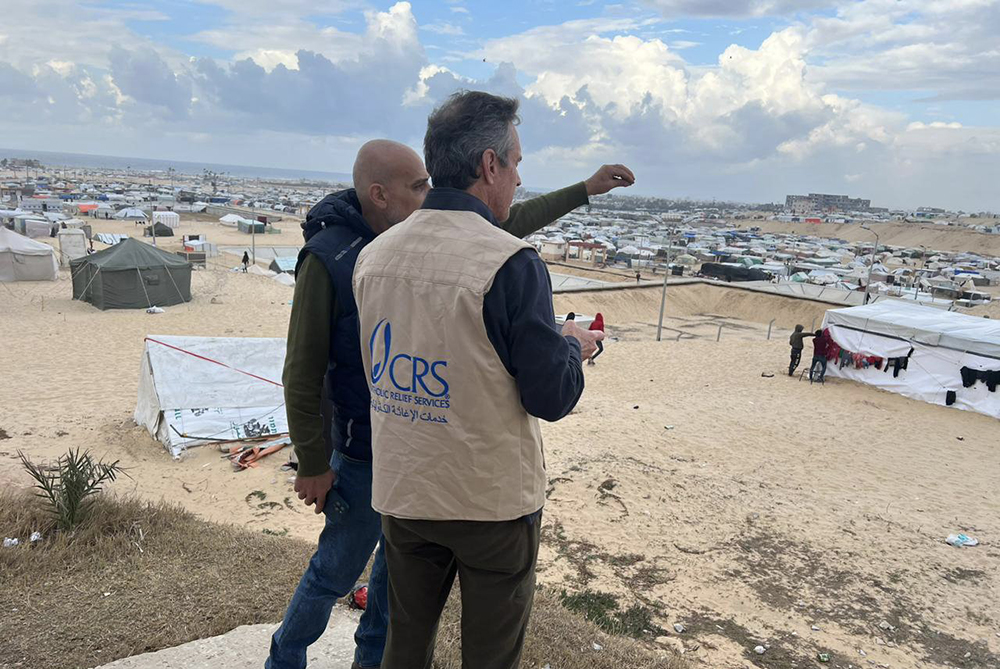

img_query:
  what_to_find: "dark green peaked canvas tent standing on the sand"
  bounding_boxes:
[70,239,191,310]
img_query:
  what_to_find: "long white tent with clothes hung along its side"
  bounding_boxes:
[823,299,1000,418]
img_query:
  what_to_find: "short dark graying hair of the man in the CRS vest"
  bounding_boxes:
[424,91,521,190]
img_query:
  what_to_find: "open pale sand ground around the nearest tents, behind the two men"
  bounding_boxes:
[0,236,1000,667]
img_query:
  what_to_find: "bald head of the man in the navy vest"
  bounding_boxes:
[354,139,430,233]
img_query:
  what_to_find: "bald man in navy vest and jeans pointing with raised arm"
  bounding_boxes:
[265,139,635,669]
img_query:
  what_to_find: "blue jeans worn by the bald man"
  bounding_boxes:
[264,451,389,669]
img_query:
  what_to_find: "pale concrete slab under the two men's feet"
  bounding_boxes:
[98,605,361,669]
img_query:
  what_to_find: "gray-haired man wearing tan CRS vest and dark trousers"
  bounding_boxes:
[354,92,612,669]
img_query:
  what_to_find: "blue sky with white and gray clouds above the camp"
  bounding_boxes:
[0,0,1000,211]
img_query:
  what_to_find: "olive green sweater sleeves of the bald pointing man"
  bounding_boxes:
[282,182,589,476]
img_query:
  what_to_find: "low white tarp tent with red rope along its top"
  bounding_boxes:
[135,335,288,457]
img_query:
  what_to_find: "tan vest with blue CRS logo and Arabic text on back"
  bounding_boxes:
[354,209,545,521]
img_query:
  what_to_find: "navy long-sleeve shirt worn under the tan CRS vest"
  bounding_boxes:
[423,188,584,421]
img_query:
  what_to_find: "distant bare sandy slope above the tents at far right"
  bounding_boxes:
[753,219,1000,256]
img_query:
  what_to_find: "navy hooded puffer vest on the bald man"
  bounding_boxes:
[296,188,375,460]
